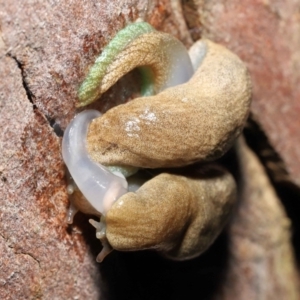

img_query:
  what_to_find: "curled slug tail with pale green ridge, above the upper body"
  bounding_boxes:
[77,22,193,106]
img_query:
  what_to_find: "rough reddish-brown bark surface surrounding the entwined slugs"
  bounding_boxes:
[0,0,300,300]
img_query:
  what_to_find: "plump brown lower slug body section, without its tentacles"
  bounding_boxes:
[106,165,236,260]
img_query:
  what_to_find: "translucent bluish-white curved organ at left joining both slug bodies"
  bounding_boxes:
[62,110,127,216]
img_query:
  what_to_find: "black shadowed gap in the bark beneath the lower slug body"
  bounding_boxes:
[100,232,227,300]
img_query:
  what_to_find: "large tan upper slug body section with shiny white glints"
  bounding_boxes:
[87,37,251,168]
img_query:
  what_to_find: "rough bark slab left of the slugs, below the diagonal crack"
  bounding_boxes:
[0,57,100,299]
